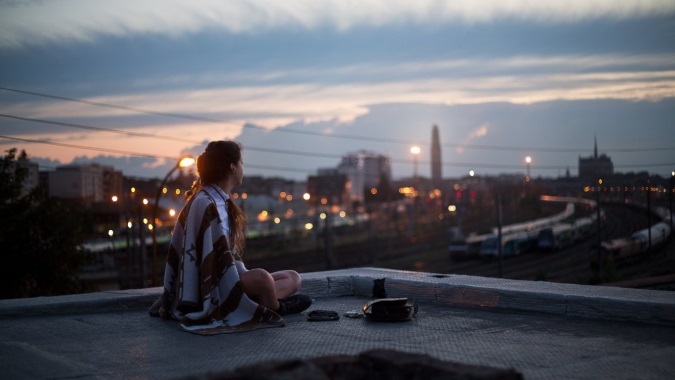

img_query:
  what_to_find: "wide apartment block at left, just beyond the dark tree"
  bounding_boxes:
[48,164,123,203]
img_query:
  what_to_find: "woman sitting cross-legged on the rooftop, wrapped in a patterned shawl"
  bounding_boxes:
[150,141,312,334]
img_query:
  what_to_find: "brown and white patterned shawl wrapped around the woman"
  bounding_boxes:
[152,191,285,335]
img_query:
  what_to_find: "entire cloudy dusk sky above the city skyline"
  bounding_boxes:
[0,0,675,181]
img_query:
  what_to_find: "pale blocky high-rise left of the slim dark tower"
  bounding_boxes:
[336,151,391,202]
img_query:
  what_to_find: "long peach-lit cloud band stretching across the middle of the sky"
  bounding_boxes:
[6,54,675,129]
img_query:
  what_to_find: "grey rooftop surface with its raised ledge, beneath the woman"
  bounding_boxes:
[0,268,675,379]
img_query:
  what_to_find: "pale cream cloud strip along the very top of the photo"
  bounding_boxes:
[0,0,675,47]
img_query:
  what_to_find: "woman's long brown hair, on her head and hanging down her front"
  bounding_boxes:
[186,141,246,257]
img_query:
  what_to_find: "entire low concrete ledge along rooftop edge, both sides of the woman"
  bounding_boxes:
[0,268,675,325]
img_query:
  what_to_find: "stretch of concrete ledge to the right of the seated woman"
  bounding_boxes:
[303,268,675,325]
